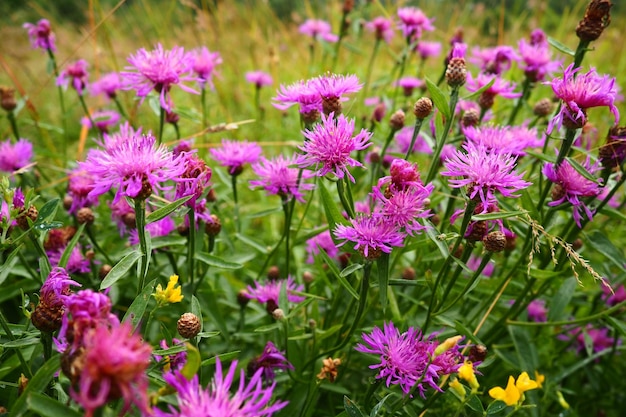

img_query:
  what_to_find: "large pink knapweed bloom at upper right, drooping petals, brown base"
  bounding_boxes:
[544,63,619,133]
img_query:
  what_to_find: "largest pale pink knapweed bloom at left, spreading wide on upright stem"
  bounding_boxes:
[78,124,185,202]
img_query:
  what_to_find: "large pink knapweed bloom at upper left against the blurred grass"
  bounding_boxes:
[121,43,200,112]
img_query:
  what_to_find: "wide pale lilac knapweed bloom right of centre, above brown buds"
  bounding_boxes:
[441,142,531,210]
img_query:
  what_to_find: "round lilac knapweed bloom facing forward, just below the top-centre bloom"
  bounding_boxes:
[296,113,372,182]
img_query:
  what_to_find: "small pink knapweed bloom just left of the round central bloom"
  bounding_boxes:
[250,155,315,203]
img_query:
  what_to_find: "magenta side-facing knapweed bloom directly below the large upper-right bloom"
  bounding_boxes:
[543,157,602,227]
